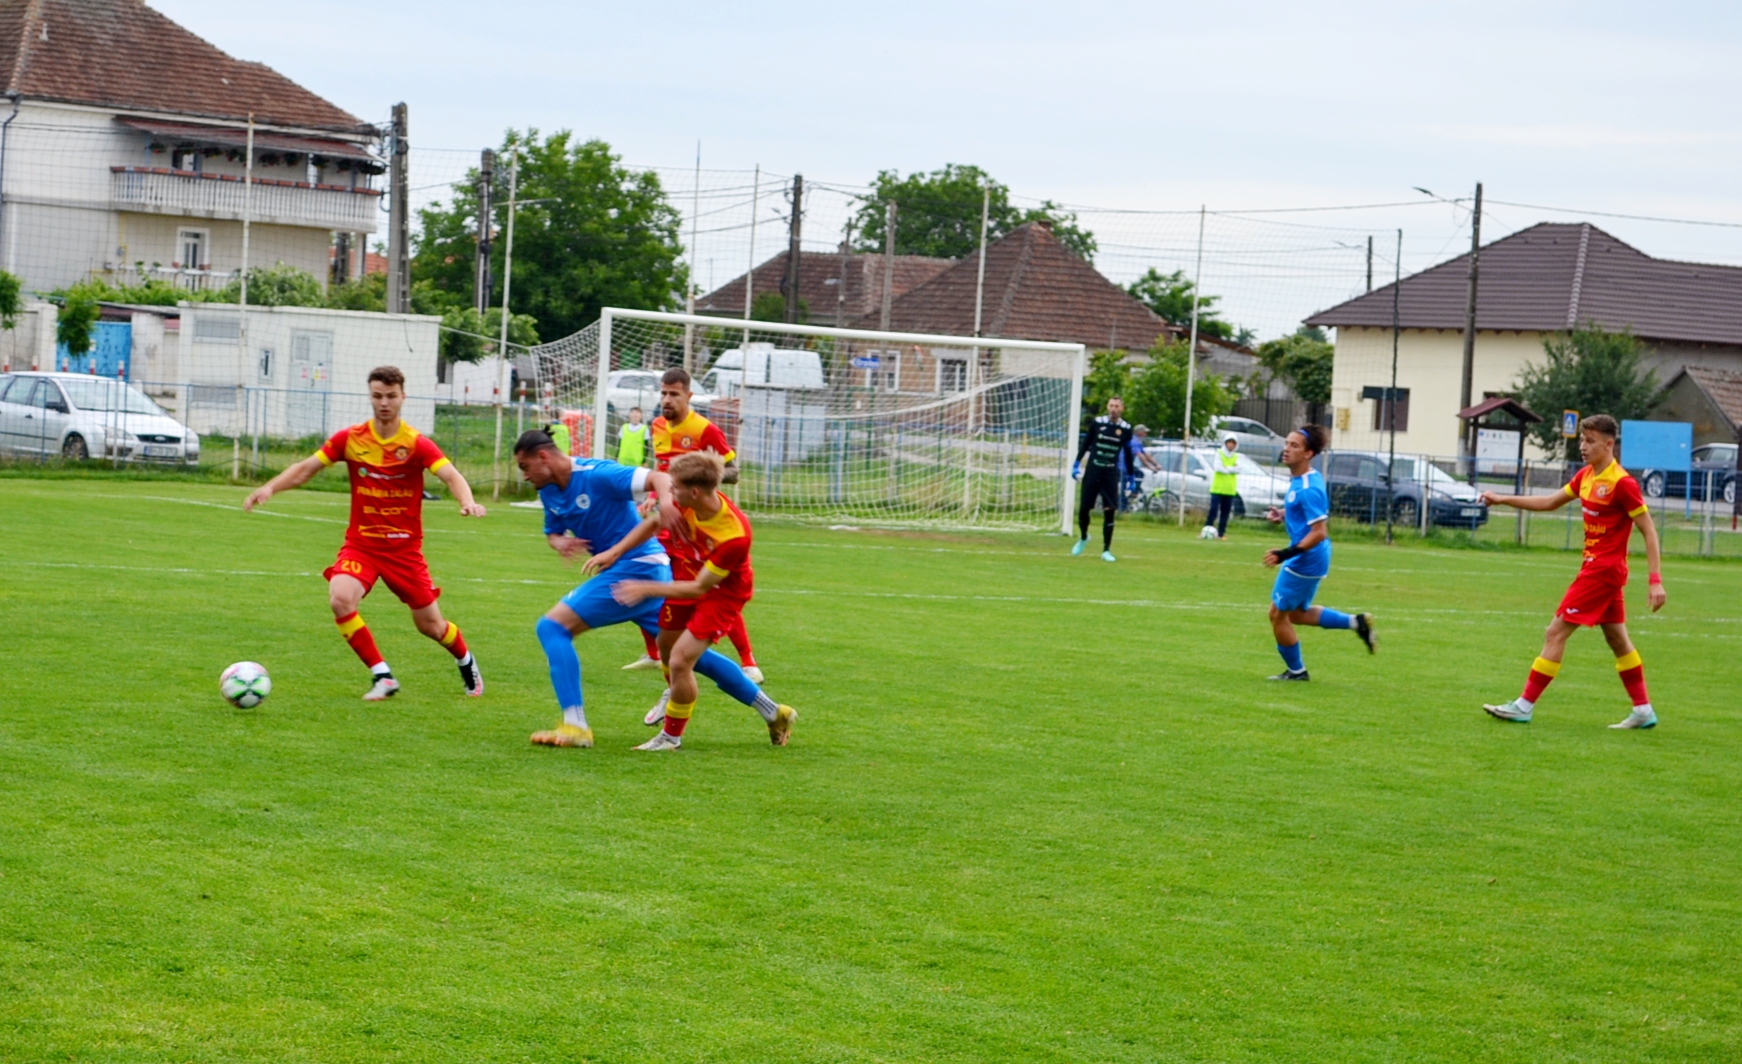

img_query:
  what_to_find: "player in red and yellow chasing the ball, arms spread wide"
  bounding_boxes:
[242,366,484,702]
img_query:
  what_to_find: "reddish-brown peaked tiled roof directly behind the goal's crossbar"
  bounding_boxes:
[854,223,1169,350]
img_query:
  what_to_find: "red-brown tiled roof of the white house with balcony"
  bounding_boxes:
[0,0,366,134]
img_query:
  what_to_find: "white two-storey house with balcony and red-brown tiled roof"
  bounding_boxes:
[0,0,385,293]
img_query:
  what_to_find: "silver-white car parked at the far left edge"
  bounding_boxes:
[0,373,200,465]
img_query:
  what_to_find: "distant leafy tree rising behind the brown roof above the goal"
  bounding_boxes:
[854,164,1096,261]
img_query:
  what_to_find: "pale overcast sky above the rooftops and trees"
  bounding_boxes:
[152,0,1742,332]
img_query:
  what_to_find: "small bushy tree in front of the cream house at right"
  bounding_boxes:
[1517,322,1658,460]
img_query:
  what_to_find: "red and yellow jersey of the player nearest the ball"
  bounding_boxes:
[315,421,449,550]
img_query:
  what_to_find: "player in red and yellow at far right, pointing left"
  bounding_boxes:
[1482,414,1665,728]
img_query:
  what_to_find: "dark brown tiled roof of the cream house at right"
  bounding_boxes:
[1307,223,1742,343]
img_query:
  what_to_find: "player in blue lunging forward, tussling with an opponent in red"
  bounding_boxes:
[514,430,678,747]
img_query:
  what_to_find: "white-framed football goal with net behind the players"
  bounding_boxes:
[528,308,1085,529]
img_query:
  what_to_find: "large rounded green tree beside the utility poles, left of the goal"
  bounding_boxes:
[411,129,688,336]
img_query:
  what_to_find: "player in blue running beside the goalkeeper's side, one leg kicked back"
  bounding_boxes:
[1265,425,1378,679]
